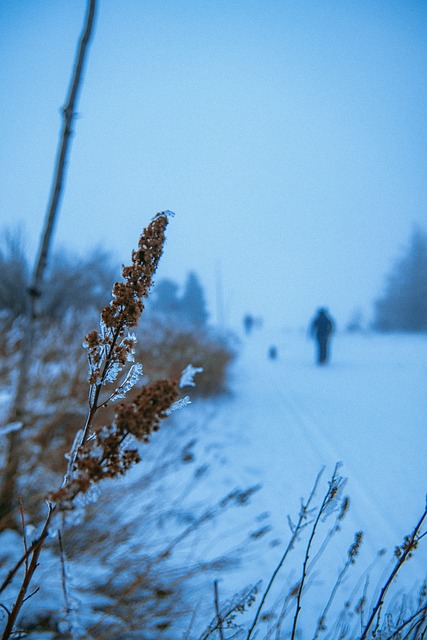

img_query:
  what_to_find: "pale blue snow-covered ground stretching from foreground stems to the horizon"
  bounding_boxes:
[1,327,427,638]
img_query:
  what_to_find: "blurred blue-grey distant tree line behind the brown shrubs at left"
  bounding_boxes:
[0,228,209,328]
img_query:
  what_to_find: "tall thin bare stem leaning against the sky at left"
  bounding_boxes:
[0,0,96,531]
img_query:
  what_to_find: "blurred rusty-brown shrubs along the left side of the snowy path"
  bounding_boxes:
[0,311,236,516]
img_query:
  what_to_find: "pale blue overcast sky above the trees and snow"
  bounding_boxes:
[0,0,427,328]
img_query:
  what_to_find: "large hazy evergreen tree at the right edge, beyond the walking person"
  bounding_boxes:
[373,227,427,331]
